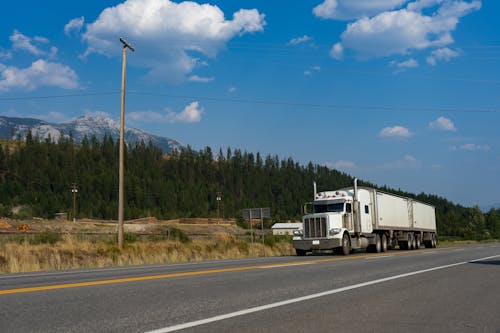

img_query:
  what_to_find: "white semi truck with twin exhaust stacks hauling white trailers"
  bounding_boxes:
[292,179,437,256]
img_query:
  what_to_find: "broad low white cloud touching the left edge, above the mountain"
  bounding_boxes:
[0,59,78,92]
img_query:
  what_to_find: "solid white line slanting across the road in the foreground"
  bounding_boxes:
[147,255,500,333]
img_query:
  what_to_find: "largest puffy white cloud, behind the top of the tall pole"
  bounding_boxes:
[83,0,266,82]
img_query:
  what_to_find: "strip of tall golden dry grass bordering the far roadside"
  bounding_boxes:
[0,232,293,273]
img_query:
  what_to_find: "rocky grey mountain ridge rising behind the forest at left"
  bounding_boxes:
[0,115,184,153]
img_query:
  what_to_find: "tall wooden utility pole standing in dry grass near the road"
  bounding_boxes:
[118,37,135,250]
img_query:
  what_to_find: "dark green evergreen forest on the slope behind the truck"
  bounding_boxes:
[0,135,500,239]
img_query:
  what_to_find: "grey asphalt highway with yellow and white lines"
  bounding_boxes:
[0,243,500,332]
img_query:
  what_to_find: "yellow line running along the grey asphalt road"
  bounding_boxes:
[0,248,444,295]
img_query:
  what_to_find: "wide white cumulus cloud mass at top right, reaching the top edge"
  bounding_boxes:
[320,0,481,64]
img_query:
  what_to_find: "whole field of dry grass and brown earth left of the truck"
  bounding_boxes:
[0,218,294,273]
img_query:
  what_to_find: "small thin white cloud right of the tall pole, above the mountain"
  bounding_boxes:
[127,101,205,123]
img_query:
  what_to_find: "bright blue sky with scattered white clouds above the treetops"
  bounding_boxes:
[0,0,500,206]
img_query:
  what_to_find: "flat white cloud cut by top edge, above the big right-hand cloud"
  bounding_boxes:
[313,0,408,20]
